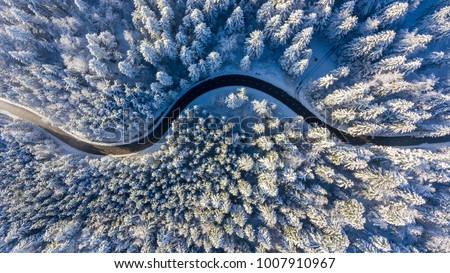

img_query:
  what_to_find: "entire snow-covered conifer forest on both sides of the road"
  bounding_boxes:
[0,0,450,252]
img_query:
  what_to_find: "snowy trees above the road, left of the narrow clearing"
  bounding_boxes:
[0,0,324,141]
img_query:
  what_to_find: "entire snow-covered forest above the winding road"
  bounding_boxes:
[0,0,450,141]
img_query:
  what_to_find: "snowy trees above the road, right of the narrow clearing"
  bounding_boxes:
[305,1,450,137]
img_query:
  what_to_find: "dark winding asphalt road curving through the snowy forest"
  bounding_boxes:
[0,75,450,155]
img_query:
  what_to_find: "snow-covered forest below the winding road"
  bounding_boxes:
[0,89,450,252]
